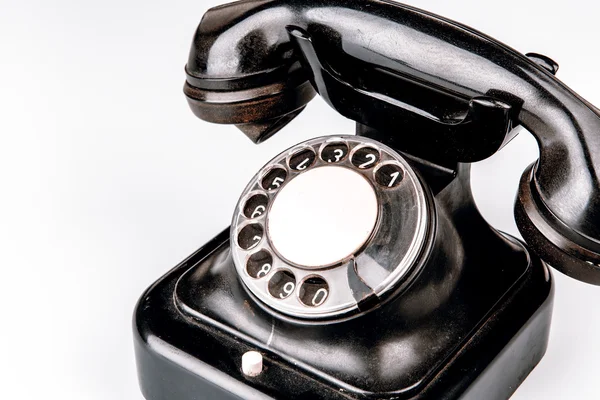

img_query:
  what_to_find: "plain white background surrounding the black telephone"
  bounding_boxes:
[0,0,600,400]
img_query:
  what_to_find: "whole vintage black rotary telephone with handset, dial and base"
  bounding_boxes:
[135,0,600,400]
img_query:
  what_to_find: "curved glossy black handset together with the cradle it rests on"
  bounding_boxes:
[186,0,600,284]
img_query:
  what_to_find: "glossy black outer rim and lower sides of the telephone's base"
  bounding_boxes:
[134,231,554,400]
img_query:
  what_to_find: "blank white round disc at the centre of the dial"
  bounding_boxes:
[267,166,378,268]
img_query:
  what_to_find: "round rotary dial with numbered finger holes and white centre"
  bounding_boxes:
[231,136,430,318]
